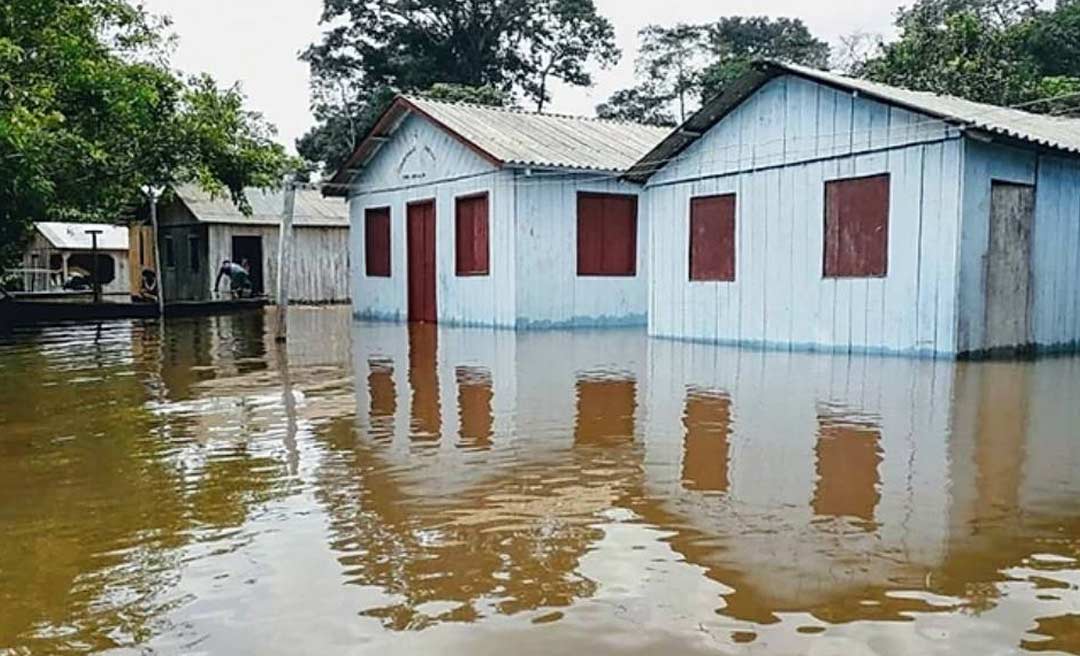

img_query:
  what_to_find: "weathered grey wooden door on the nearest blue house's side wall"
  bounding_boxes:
[984,180,1035,350]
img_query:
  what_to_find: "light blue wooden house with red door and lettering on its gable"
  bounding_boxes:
[330,96,669,327]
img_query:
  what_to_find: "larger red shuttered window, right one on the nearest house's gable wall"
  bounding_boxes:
[824,174,889,278]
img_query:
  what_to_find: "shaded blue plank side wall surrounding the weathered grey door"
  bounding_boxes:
[959,140,1080,351]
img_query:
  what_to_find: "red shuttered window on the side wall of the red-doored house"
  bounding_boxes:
[578,193,637,276]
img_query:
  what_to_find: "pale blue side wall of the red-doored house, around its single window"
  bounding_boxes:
[516,173,649,327]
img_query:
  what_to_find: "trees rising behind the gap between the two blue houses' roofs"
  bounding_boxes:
[596,16,829,125]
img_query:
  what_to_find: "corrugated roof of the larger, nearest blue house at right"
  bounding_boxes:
[626,62,1080,182]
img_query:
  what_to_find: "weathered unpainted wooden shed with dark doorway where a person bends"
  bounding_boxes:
[158,186,349,304]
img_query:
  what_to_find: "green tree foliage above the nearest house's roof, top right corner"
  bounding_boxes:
[855,0,1080,113]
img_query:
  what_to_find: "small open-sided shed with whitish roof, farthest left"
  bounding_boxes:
[21,222,131,300]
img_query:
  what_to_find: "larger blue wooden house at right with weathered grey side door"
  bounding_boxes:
[626,63,1080,357]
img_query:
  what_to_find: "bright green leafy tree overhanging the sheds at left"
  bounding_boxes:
[0,0,291,267]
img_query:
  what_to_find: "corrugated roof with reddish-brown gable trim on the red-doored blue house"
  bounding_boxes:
[332,95,671,193]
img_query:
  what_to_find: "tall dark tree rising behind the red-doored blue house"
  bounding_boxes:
[297,0,619,171]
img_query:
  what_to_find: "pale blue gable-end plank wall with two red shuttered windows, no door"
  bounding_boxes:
[646,77,962,353]
